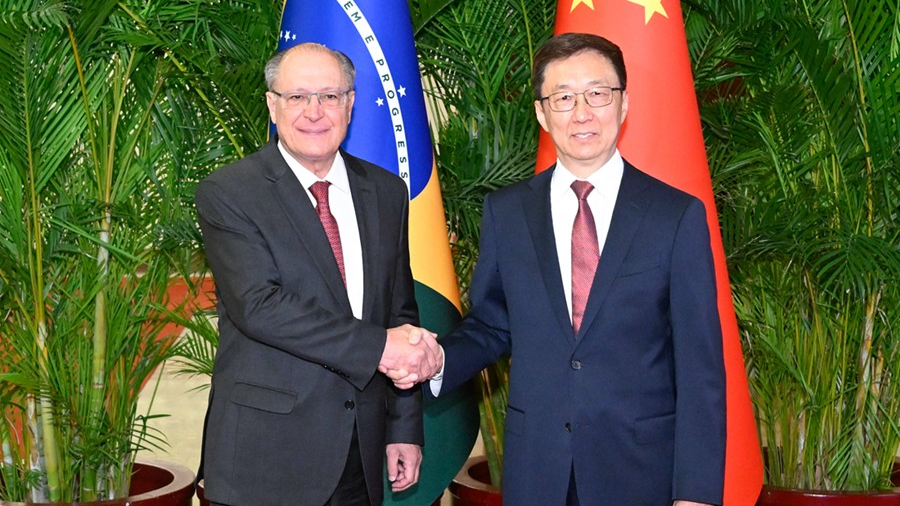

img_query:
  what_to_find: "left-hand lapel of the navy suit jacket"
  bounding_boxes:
[522,166,575,341]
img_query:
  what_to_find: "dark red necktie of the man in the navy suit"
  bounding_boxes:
[572,181,600,335]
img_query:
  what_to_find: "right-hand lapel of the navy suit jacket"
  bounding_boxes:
[578,162,648,338]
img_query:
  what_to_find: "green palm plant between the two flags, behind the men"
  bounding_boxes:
[410,0,556,485]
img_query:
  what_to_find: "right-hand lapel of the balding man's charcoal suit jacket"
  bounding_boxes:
[341,151,381,321]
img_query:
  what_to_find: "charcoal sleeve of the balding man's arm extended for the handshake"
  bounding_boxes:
[196,180,386,390]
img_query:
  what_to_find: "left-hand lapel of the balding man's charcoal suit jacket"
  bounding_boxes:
[263,138,352,313]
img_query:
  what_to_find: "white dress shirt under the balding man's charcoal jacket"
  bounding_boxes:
[278,141,363,319]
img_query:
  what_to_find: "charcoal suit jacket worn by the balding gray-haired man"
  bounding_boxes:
[196,140,424,506]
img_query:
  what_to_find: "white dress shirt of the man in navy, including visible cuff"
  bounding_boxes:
[429,149,625,397]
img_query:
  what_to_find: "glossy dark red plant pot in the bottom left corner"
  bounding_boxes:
[0,460,194,506]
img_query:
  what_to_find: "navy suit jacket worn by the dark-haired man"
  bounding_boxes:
[441,162,725,506]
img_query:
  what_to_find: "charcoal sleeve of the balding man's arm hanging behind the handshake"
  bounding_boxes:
[385,195,425,446]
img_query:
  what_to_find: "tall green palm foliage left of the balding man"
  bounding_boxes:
[0,0,277,502]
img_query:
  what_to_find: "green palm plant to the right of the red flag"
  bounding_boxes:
[687,0,900,490]
